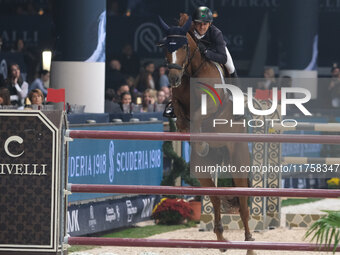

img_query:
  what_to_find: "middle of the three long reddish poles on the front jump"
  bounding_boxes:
[67,183,340,198]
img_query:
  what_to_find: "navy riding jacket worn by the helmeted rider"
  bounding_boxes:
[200,25,228,64]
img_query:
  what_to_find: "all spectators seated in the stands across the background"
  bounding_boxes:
[0,37,340,113]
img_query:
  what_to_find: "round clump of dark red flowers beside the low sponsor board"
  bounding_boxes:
[152,198,192,225]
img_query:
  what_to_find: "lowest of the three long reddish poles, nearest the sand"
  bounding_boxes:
[65,237,340,252]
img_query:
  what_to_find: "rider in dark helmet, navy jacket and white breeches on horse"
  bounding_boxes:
[163,6,237,118]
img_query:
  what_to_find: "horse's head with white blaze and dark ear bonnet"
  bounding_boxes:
[159,17,191,87]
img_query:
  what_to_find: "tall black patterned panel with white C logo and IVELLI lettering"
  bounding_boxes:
[0,111,58,253]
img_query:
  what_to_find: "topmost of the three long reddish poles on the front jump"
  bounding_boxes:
[65,130,340,144]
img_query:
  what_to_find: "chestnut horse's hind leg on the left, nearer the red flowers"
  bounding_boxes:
[198,178,226,242]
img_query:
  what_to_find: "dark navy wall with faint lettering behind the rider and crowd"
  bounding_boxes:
[0,0,340,73]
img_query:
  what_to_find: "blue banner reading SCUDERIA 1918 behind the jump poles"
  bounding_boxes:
[68,123,163,202]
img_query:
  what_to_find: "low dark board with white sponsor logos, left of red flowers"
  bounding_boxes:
[67,195,160,236]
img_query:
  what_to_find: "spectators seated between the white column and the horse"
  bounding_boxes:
[105,44,171,113]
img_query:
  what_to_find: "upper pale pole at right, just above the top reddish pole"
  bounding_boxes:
[273,121,340,132]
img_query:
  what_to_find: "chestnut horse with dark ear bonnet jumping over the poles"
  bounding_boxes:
[160,14,254,251]
